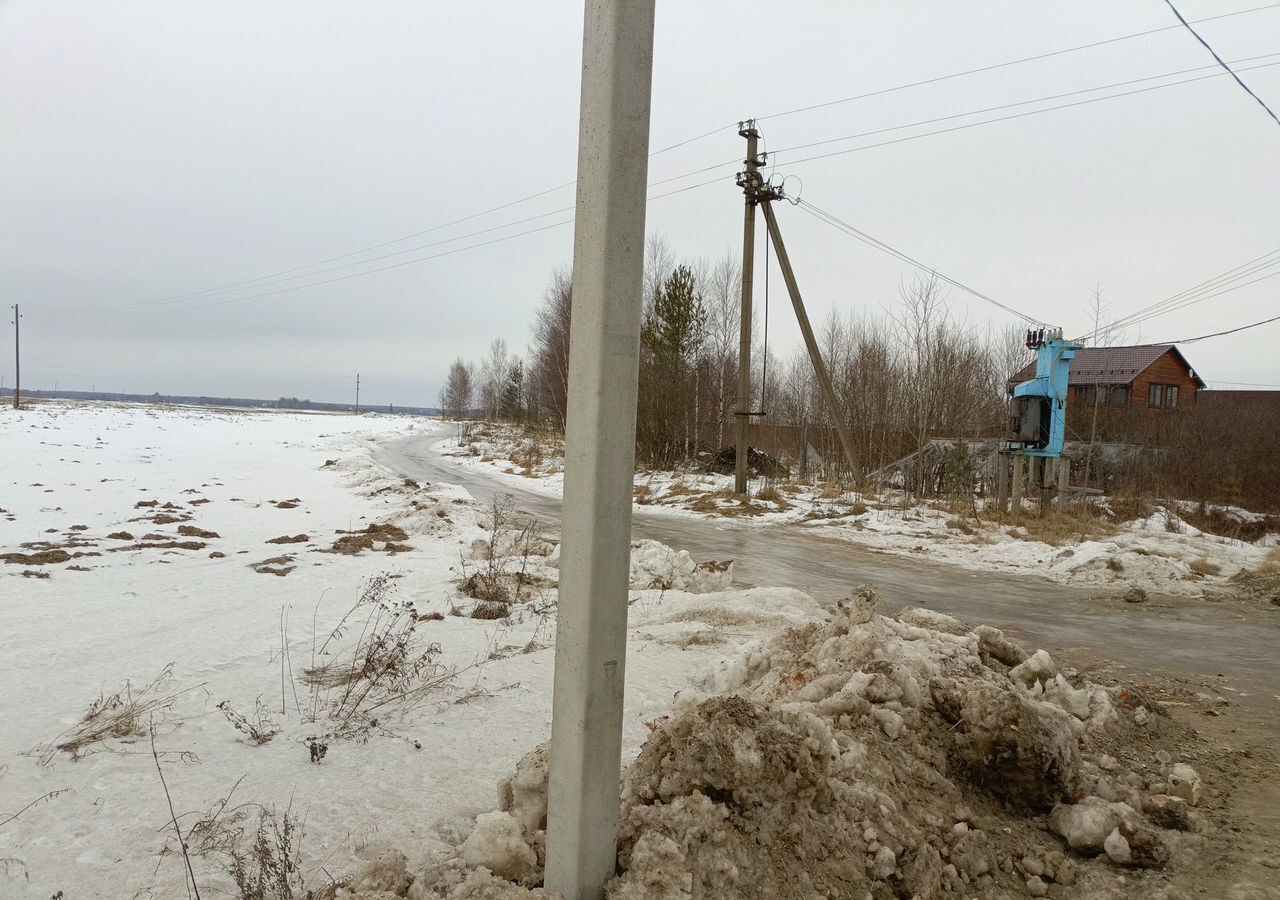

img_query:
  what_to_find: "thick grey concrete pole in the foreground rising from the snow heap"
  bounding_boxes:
[545,0,654,900]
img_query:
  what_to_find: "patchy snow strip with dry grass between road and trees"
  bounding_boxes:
[442,425,1280,598]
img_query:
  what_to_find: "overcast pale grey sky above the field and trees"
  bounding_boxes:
[0,0,1280,405]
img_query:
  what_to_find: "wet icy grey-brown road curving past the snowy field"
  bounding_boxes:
[378,434,1280,718]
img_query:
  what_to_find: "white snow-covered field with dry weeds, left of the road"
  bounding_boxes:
[0,403,788,900]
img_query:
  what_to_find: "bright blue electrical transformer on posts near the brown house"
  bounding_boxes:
[1007,329,1080,458]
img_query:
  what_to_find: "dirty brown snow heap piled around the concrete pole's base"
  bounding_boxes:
[338,588,1201,900]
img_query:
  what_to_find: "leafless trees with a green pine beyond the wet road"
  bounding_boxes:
[440,237,1030,478]
